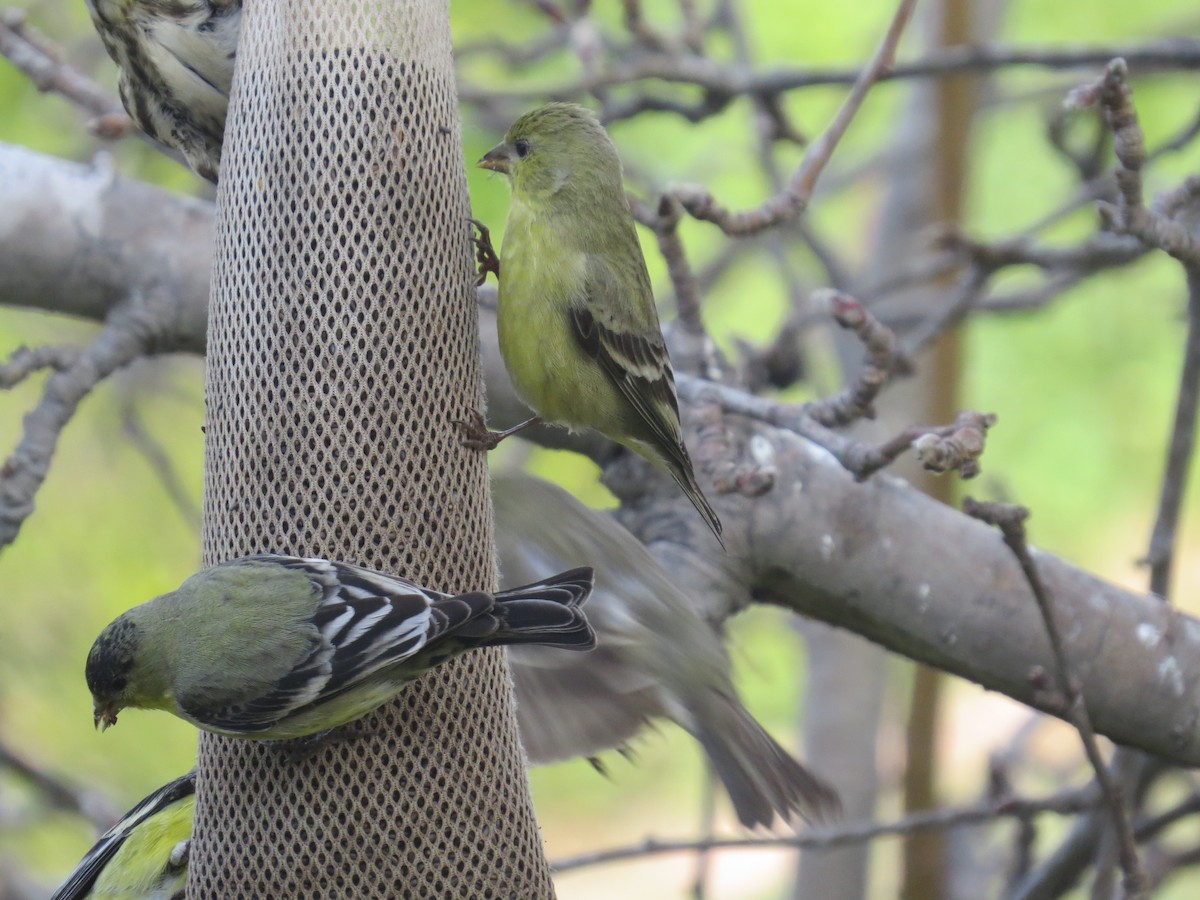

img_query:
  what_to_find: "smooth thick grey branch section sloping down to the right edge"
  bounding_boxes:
[744,436,1200,764]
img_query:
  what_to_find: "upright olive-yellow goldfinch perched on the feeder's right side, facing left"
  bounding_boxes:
[468,103,721,540]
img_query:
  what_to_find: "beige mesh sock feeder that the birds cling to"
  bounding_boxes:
[188,0,553,900]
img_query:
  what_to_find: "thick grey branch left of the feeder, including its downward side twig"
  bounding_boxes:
[0,148,212,548]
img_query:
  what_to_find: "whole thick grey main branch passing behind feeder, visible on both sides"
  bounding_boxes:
[7,146,1200,764]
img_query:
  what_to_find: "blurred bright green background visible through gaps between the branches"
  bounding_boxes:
[0,0,1200,900]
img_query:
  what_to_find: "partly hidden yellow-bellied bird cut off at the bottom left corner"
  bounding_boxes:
[50,772,196,900]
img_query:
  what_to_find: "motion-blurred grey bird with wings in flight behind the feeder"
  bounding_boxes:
[492,476,840,828]
